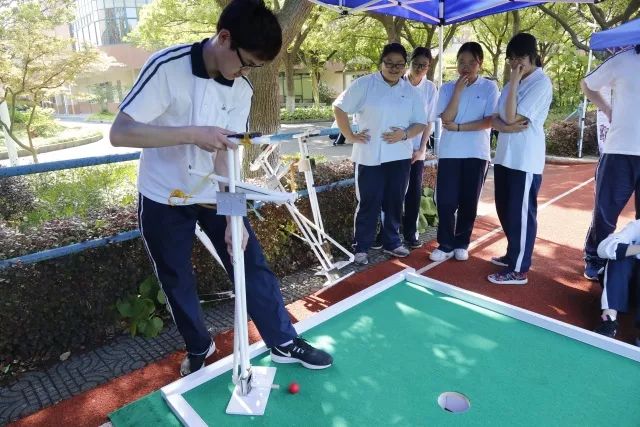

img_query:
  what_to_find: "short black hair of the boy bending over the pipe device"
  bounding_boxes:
[216,0,282,61]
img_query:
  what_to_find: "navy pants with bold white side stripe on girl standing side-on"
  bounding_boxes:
[493,165,542,273]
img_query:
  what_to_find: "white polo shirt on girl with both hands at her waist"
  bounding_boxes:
[333,72,427,166]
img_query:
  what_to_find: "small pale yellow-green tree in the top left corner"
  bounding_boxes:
[0,0,109,162]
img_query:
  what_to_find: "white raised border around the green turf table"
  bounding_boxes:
[161,268,640,427]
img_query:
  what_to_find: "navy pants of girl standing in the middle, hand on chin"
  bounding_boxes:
[435,158,489,252]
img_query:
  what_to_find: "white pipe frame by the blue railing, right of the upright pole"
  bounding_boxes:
[250,131,354,286]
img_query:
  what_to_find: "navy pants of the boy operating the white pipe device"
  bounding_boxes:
[138,195,297,354]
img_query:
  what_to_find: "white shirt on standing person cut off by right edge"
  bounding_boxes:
[584,48,640,156]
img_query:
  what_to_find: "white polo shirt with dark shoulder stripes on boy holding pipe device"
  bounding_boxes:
[120,39,253,204]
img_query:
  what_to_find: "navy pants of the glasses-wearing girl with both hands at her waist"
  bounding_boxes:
[353,159,411,253]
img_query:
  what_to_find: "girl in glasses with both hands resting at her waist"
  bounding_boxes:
[333,43,427,264]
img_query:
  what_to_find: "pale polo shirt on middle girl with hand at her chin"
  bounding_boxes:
[436,76,500,160]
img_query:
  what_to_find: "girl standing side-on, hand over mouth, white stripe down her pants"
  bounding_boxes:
[488,33,553,285]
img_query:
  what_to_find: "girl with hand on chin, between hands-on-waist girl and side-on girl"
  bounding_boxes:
[430,42,499,261]
